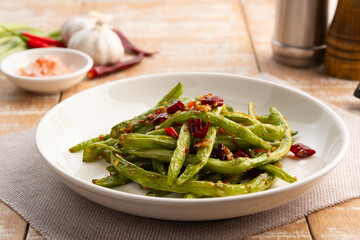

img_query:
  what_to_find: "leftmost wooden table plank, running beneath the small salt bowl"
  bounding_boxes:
[0,0,81,239]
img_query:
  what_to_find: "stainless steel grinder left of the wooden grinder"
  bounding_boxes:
[272,0,328,67]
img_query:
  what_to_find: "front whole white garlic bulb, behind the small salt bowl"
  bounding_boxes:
[68,20,125,65]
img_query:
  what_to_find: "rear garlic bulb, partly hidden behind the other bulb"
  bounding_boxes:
[60,16,97,45]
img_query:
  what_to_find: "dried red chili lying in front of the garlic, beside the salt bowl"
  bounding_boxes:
[87,53,144,79]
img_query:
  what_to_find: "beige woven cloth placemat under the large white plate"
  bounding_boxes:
[0,75,360,239]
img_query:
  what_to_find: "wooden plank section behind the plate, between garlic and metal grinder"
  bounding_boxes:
[63,0,258,99]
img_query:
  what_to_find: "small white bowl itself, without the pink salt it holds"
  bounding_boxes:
[0,48,93,93]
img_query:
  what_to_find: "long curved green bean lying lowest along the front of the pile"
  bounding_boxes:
[110,155,274,197]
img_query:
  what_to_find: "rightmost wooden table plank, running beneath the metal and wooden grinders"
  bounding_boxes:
[241,0,360,239]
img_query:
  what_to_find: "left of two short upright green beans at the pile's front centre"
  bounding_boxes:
[167,122,191,186]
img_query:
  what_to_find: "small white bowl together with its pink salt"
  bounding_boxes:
[1,48,93,93]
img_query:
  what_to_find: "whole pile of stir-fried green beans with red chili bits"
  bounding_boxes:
[69,83,297,199]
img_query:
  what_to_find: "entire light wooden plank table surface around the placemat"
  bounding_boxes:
[0,0,360,239]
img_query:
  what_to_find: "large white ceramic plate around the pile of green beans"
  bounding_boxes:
[36,73,349,220]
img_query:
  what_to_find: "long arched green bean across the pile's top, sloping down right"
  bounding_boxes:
[160,112,271,149]
